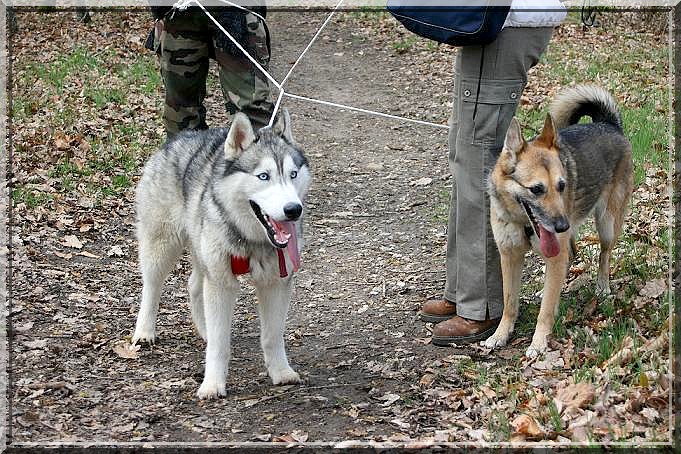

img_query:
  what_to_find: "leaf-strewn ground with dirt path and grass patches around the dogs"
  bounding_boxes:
[11,11,670,446]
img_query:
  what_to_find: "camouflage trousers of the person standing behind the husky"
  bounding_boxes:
[154,8,274,136]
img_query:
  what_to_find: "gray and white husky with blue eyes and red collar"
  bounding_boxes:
[132,110,311,398]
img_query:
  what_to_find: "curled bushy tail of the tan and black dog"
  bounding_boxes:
[549,85,622,131]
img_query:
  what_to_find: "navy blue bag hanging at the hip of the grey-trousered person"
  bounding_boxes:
[387,0,511,46]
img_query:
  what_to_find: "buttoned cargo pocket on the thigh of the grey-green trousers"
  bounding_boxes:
[459,80,525,144]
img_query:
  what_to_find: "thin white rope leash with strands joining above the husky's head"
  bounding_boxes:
[173,0,449,129]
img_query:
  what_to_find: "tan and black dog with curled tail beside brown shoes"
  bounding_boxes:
[483,85,633,357]
